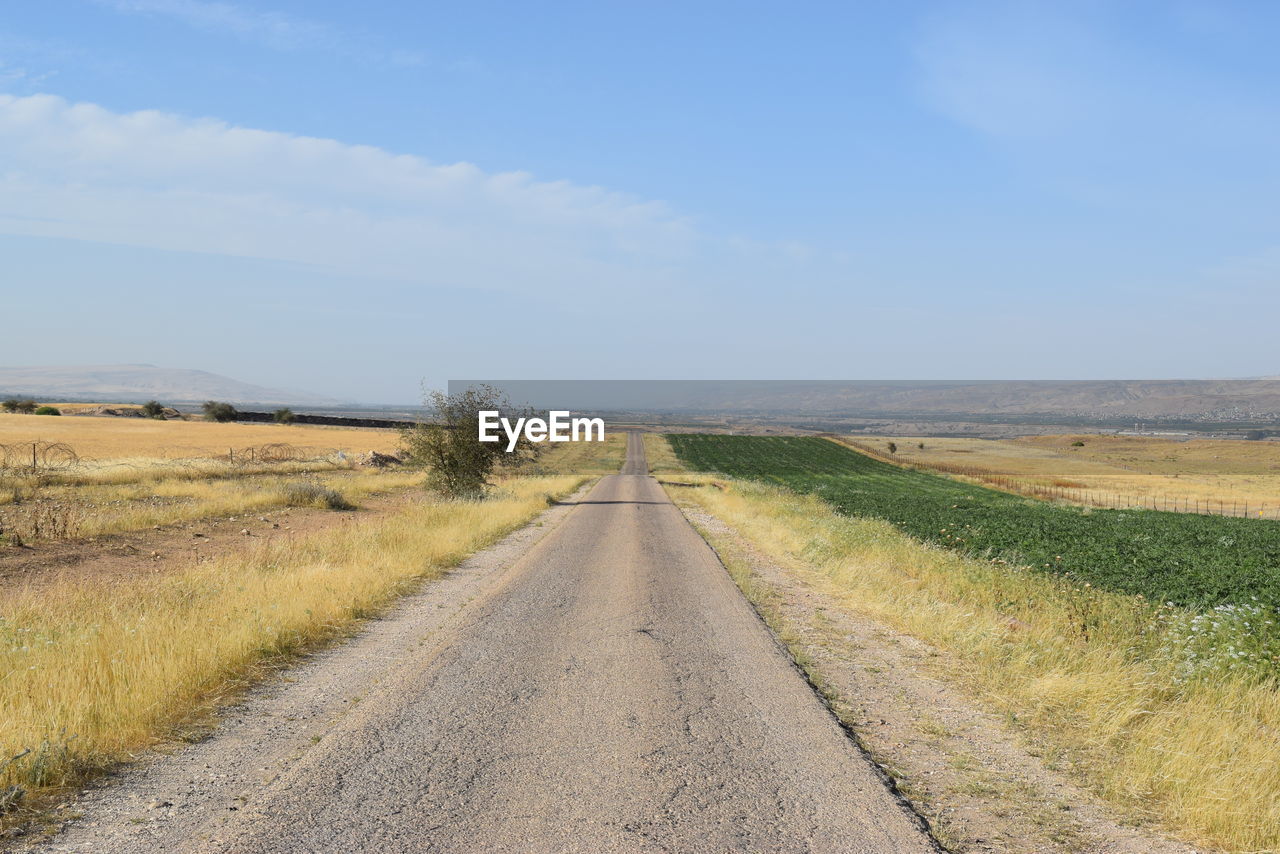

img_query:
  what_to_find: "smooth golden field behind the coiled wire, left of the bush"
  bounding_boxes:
[0,414,399,461]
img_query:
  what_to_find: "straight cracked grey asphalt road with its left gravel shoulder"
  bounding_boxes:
[32,434,937,854]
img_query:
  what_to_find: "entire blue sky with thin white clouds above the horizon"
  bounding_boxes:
[0,0,1280,403]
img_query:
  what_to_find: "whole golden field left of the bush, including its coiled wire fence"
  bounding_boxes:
[0,415,409,545]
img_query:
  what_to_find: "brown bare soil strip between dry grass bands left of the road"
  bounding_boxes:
[0,490,417,589]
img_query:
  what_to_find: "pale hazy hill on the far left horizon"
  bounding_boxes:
[0,365,340,406]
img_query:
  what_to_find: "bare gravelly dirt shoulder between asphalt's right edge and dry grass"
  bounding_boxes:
[682,506,1204,854]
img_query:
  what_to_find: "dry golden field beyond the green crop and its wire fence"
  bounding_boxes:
[841,434,1280,519]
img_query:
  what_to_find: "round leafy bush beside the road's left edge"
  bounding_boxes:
[401,385,536,498]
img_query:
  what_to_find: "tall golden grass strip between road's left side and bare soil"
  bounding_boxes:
[0,475,586,814]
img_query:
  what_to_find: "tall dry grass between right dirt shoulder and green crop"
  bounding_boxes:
[669,475,1280,851]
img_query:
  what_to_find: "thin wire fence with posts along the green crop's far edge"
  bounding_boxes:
[841,439,1280,521]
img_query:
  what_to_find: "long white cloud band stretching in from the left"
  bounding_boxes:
[0,95,701,294]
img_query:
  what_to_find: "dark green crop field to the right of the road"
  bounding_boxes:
[667,434,1280,608]
